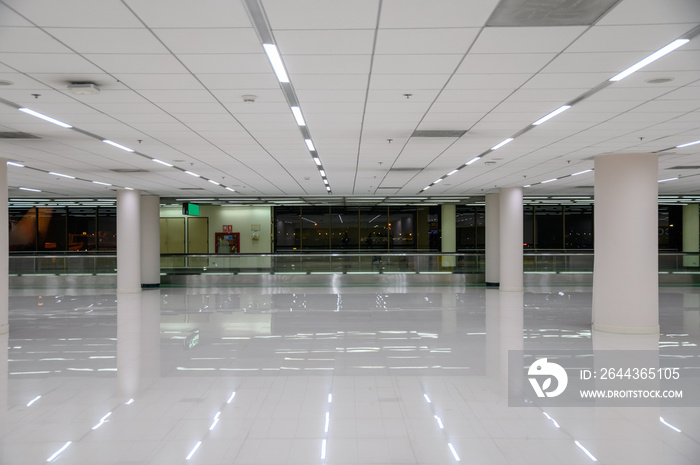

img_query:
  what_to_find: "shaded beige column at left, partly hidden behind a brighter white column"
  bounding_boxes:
[141,195,160,287]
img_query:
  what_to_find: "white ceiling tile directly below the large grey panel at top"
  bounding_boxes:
[470,26,586,53]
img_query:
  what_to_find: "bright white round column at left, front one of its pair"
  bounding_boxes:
[117,189,141,292]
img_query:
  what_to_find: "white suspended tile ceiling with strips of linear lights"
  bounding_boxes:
[0,0,700,201]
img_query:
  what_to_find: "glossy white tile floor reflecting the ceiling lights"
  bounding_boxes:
[0,287,700,465]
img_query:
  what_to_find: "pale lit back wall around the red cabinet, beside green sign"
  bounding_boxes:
[160,205,272,253]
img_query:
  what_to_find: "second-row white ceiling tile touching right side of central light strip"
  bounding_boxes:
[275,29,374,56]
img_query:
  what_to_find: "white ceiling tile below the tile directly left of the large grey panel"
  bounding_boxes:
[375,28,479,55]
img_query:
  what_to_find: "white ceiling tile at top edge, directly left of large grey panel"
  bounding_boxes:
[379,0,498,28]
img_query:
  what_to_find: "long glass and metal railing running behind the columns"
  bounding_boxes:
[9,251,700,276]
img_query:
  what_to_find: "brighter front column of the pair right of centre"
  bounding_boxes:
[498,187,523,291]
